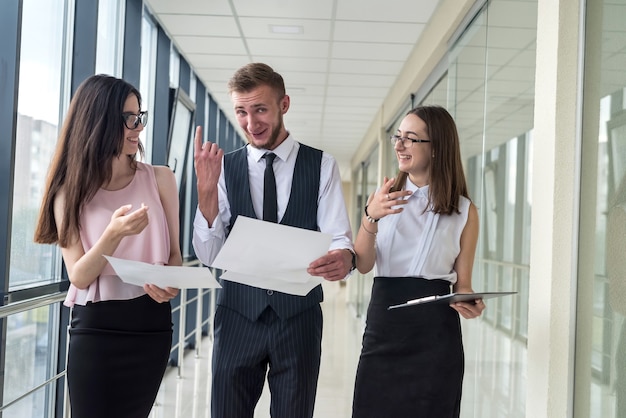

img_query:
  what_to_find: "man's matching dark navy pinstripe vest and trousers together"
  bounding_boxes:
[211,144,323,418]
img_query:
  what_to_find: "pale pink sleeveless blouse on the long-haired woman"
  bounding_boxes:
[64,162,170,307]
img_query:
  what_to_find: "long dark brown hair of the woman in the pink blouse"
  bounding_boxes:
[34,75,143,247]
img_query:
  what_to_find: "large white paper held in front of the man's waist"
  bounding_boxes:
[211,216,332,296]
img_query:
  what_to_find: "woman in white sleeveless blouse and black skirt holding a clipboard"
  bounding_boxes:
[353,106,485,418]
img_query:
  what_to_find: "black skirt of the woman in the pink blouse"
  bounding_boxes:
[67,295,172,418]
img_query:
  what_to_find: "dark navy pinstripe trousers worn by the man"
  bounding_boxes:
[211,305,322,418]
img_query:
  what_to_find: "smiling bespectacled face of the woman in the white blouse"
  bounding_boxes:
[394,114,432,186]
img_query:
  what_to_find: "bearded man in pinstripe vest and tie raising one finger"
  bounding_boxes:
[193,63,355,418]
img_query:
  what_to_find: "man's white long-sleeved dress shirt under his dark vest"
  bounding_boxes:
[193,135,353,265]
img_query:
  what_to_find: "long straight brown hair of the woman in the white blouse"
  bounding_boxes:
[391,106,469,215]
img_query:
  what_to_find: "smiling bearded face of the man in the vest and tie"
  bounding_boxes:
[231,85,289,150]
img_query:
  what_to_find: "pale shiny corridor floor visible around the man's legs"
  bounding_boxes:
[150,283,363,418]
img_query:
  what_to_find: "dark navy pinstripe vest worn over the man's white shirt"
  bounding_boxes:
[217,144,323,321]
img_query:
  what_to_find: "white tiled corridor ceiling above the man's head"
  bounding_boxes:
[146,0,439,179]
